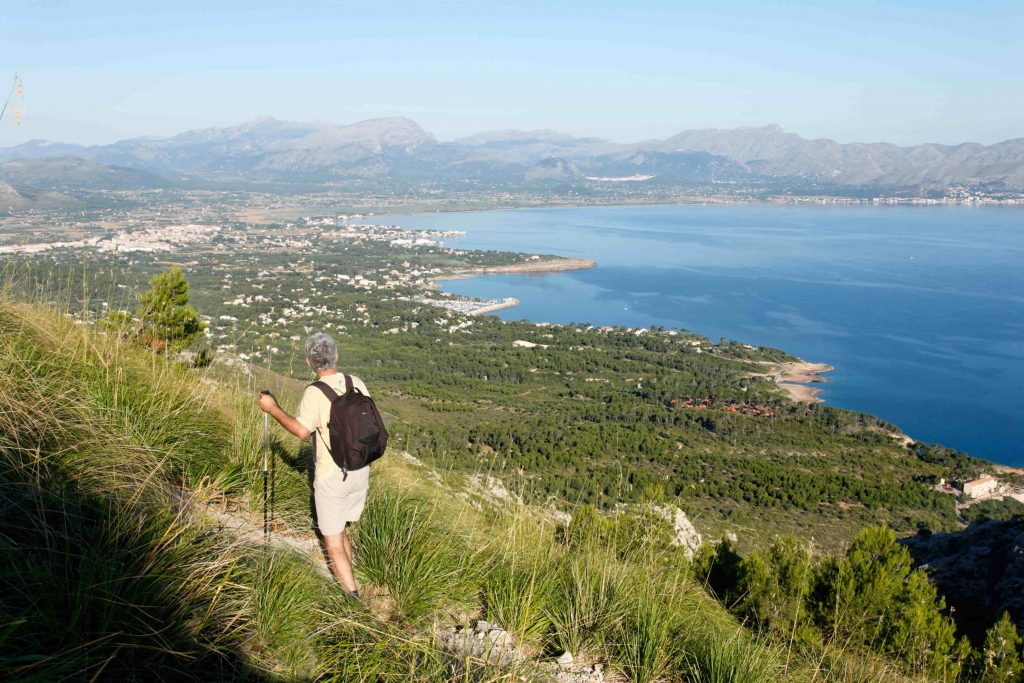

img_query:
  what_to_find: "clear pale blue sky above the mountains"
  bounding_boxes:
[0,0,1024,144]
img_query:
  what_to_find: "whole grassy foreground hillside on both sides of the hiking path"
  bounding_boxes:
[0,299,921,681]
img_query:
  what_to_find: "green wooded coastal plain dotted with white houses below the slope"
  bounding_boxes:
[2,216,984,550]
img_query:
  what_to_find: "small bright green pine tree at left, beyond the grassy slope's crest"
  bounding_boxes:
[138,267,204,351]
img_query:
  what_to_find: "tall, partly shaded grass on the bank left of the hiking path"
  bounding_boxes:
[0,299,507,681]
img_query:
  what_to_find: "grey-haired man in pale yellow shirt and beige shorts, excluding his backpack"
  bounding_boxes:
[259,332,370,597]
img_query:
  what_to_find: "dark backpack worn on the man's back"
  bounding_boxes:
[309,375,387,479]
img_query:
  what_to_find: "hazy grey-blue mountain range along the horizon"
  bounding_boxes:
[0,118,1024,194]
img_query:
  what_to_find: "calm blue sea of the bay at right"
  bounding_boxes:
[372,206,1024,465]
